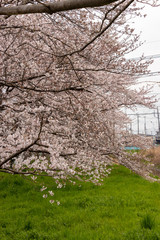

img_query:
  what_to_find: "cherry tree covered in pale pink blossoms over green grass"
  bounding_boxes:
[0,0,156,183]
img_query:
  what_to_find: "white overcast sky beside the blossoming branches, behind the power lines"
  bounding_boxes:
[127,2,160,134]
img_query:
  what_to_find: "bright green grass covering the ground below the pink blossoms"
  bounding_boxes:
[0,166,160,240]
